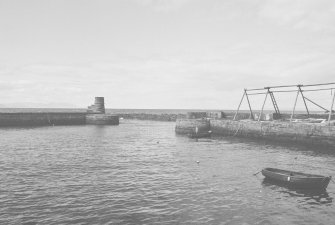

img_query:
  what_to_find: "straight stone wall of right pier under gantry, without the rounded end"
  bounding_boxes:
[210,120,335,148]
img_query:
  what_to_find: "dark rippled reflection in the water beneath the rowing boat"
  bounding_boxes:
[262,179,333,205]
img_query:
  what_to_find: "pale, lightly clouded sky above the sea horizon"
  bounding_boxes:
[0,0,335,109]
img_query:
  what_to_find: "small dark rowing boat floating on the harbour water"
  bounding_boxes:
[262,168,332,189]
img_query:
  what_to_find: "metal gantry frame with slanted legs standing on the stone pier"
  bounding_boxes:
[233,83,335,125]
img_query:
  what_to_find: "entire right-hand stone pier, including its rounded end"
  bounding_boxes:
[175,119,335,148]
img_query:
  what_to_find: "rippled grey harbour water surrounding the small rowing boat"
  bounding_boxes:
[0,120,335,225]
